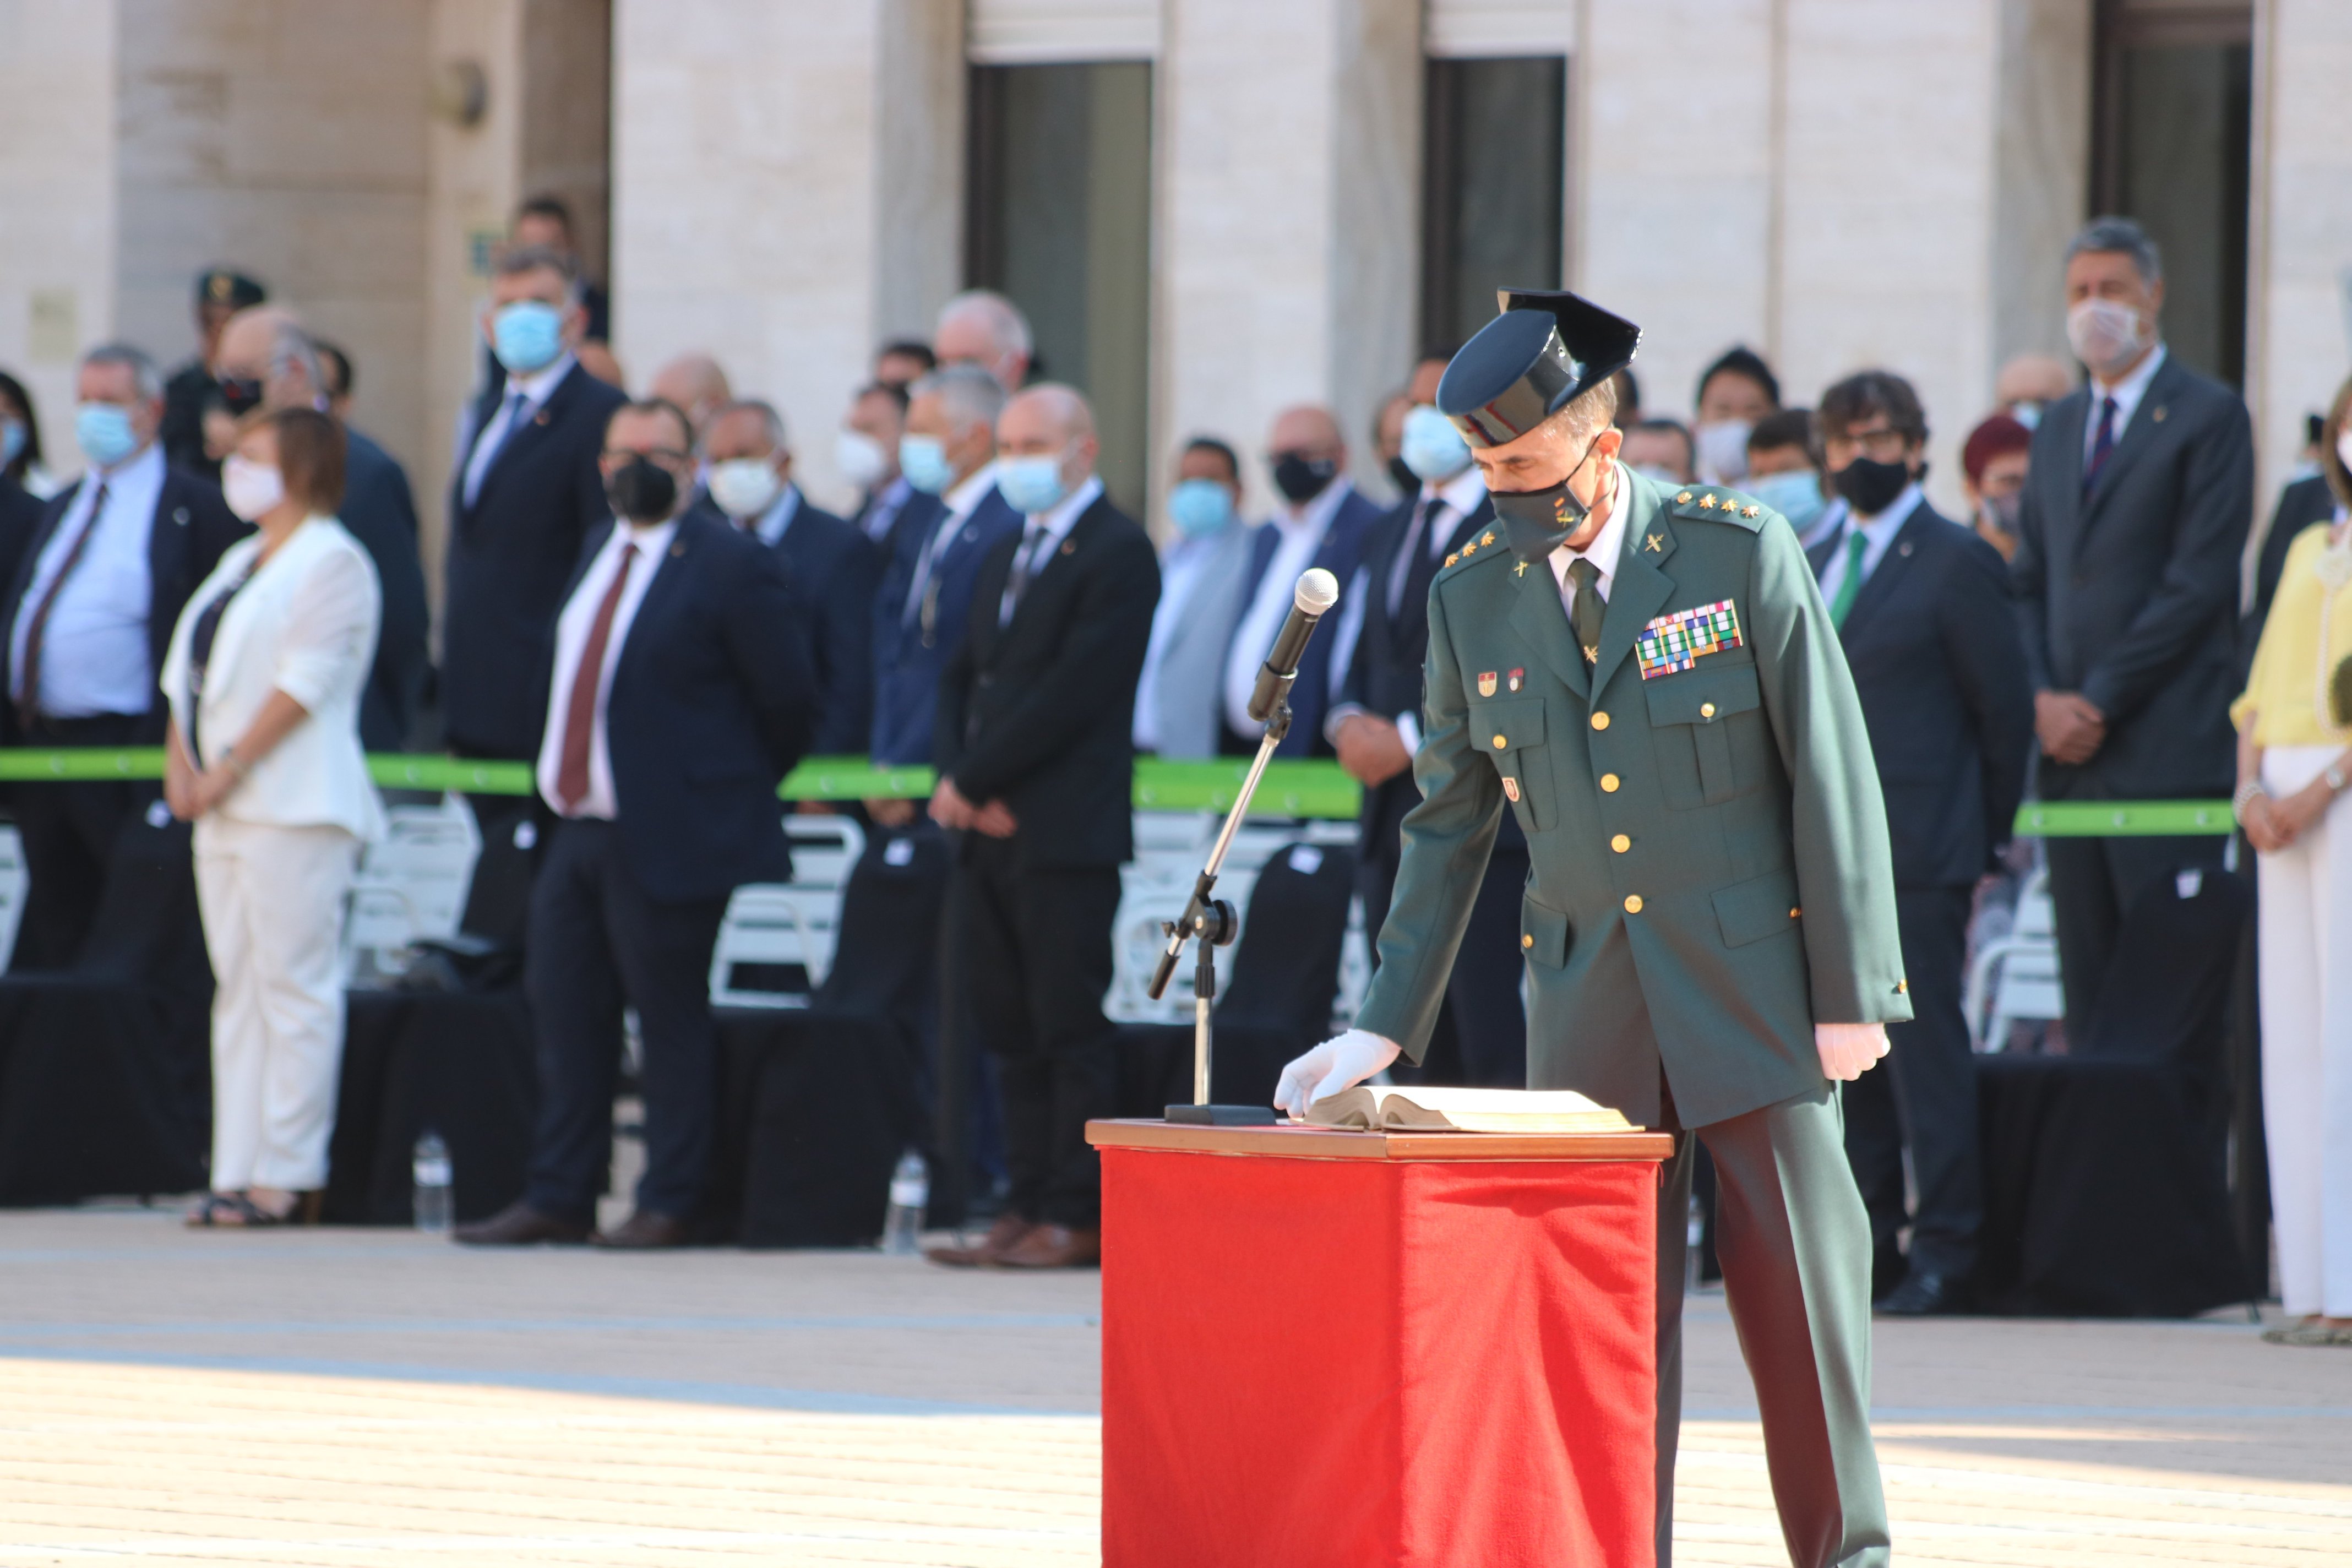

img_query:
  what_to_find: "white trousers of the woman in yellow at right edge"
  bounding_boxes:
[2258,745,2352,1316]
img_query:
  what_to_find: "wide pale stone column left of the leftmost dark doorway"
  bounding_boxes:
[612,0,962,505]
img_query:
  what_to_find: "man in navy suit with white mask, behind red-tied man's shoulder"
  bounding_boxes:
[703,402,882,757]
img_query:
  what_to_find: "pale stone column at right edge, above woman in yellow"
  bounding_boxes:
[2246,0,2352,512]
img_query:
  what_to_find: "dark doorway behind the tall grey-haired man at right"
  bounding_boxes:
[2091,0,2253,385]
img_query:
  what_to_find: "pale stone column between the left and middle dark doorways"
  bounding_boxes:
[1150,0,1420,513]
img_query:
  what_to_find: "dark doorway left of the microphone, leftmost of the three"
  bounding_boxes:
[965,61,1152,517]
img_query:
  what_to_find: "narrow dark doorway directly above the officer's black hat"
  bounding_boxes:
[1420,56,1569,343]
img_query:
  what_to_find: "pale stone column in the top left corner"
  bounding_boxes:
[0,0,118,475]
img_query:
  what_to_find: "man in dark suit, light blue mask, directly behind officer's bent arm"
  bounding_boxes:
[1324,350,1527,1088]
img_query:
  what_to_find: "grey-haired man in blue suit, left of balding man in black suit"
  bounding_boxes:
[868,364,1021,785]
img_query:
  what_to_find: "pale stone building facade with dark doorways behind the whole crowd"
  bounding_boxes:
[0,0,2352,582]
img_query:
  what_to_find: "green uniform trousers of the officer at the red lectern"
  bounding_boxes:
[1658,1068,1888,1568]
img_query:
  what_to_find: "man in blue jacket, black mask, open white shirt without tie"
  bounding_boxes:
[1226,404,1381,757]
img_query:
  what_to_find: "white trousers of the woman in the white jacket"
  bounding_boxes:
[195,816,360,1192]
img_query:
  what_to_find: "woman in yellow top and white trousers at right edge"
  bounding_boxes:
[2230,381,2352,1344]
